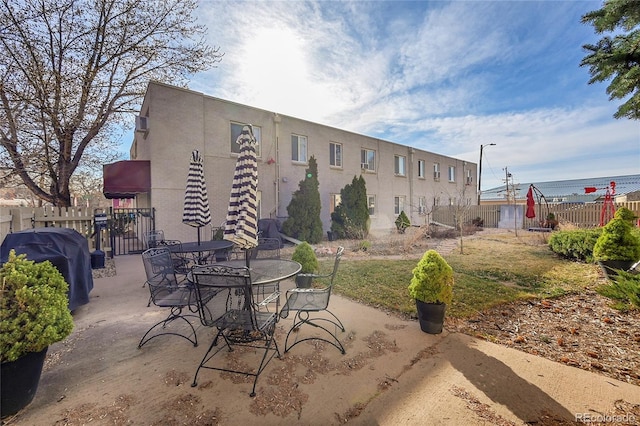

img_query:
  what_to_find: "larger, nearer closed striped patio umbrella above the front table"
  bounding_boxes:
[224,125,258,261]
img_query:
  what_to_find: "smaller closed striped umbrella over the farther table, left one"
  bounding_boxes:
[182,151,211,244]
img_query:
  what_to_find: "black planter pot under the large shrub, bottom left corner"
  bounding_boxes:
[0,348,48,417]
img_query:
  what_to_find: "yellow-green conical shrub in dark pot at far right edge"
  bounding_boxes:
[593,207,640,278]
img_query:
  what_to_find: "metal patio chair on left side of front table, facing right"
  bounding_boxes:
[138,247,198,349]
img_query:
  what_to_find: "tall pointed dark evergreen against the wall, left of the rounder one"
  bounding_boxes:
[282,156,322,244]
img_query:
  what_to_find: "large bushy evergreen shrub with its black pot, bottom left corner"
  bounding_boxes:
[0,250,73,417]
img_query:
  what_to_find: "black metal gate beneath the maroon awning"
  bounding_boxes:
[107,207,156,256]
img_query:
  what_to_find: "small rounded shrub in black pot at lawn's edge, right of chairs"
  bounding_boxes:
[409,250,453,334]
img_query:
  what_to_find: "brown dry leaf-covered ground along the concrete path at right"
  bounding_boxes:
[447,291,640,386]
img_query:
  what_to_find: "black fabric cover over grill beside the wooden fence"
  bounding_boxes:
[0,228,93,311]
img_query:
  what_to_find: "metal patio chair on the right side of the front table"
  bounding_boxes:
[280,247,346,354]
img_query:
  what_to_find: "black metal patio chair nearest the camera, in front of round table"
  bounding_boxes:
[191,264,280,397]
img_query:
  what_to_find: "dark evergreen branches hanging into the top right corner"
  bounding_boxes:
[580,0,640,120]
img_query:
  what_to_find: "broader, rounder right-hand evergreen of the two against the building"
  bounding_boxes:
[331,176,369,239]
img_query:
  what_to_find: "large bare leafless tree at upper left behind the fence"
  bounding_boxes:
[0,0,222,206]
